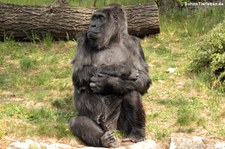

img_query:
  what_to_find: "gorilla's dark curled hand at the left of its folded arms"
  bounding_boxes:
[90,74,110,93]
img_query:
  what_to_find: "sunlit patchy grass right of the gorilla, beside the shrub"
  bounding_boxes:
[142,6,225,140]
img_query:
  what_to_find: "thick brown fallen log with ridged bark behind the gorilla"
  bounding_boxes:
[0,3,160,41]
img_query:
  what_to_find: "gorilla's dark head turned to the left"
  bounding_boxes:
[87,4,128,49]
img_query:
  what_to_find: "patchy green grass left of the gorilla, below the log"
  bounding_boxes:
[0,40,76,138]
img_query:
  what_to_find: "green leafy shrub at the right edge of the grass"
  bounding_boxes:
[191,21,225,92]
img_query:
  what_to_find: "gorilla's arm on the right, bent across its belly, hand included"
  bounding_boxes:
[90,37,152,94]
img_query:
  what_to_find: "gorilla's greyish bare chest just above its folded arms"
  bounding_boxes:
[92,48,129,66]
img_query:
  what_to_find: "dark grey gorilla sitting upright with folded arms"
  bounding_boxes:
[70,4,151,147]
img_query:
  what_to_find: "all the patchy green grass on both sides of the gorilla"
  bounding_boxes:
[0,3,225,147]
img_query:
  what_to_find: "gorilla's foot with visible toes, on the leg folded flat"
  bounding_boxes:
[101,131,118,147]
